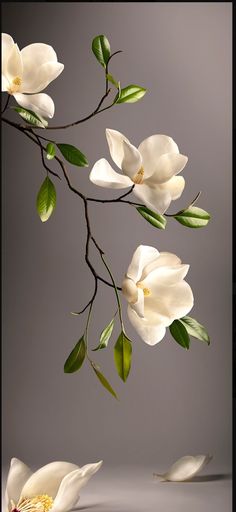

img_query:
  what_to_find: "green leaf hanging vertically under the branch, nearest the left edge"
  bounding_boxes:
[36,176,56,222]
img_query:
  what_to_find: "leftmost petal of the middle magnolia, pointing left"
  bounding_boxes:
[89,158,133,189]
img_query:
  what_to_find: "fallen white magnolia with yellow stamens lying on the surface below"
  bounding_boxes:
[6,458,102,512]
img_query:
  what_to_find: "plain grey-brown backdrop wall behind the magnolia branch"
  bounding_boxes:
[2,2,232,511]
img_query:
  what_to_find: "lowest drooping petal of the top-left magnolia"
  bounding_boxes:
[13,92,55,118]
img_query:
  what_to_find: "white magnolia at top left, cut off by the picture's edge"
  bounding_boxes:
[2,34,64,118]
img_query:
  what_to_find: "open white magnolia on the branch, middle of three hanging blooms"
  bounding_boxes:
[89,129,188,214]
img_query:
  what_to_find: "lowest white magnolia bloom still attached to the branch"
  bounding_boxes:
[122,245,193,345]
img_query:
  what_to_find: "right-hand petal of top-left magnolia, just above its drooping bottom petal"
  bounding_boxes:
[22,62,64,93]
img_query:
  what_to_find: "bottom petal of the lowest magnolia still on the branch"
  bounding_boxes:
[127,306,166,345]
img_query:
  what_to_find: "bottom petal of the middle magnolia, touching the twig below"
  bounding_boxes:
[133,183,171,215]
